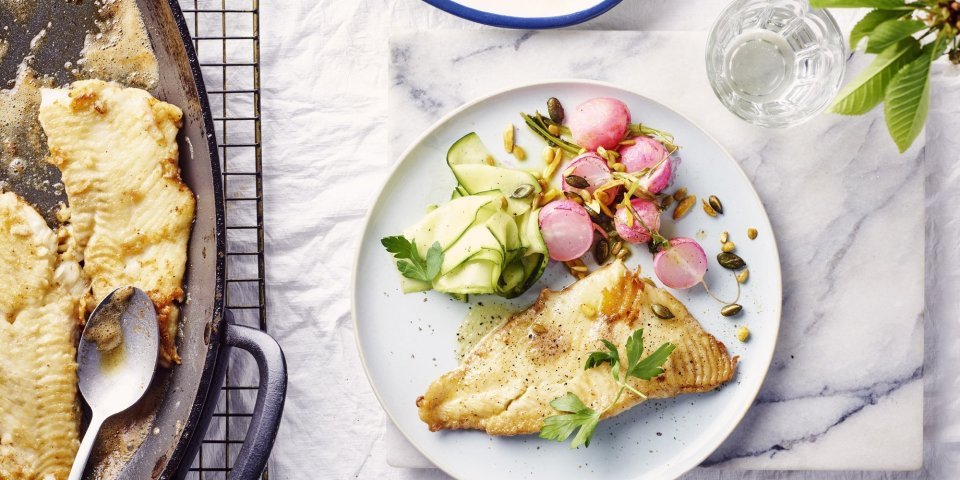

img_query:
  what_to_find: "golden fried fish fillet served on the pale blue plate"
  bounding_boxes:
[417,261,737,435]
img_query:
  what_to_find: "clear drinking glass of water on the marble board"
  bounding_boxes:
[706,0,845,127]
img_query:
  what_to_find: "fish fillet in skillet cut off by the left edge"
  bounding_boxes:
[0,193,88,480]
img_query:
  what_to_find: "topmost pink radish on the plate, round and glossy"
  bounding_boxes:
[567,97,630,151]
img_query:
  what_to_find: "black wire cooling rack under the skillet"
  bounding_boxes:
[179,0,269,479]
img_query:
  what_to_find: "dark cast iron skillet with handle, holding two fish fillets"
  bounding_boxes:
[0,0,287,480]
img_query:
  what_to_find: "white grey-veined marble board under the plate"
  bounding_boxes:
[387,31,924,470]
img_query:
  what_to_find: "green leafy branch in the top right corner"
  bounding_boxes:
[810,0,960,153]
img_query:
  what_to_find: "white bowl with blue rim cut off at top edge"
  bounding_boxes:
[424,0,621,30]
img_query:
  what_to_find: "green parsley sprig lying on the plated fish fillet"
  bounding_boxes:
[540,328,677,448]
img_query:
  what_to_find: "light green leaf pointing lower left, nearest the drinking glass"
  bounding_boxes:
[830,37,920,115]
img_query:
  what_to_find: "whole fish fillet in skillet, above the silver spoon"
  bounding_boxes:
[40,80,196,365]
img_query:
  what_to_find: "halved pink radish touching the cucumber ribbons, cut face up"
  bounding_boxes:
[539,200,593,262]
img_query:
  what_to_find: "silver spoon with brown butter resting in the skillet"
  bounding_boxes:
[70,287,160,480]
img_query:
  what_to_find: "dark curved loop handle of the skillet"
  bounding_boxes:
[226,323,287,480]
